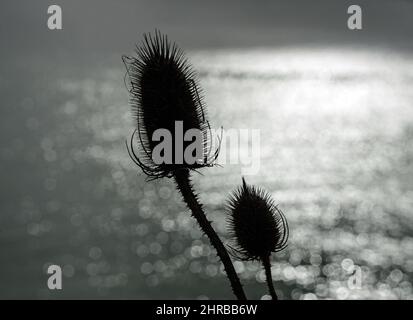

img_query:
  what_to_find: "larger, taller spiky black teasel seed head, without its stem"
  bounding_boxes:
[122,31,219,178]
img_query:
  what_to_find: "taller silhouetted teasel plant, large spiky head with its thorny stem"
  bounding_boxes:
[123,31,246,299]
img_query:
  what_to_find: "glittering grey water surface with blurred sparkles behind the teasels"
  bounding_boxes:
[0,49,413,299]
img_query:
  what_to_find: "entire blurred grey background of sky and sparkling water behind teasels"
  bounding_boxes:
[0,0,413,299]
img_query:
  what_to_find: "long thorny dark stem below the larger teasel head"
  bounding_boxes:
[174,170,247,300]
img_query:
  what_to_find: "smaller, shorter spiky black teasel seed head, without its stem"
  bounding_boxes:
[227,178,288,260]
